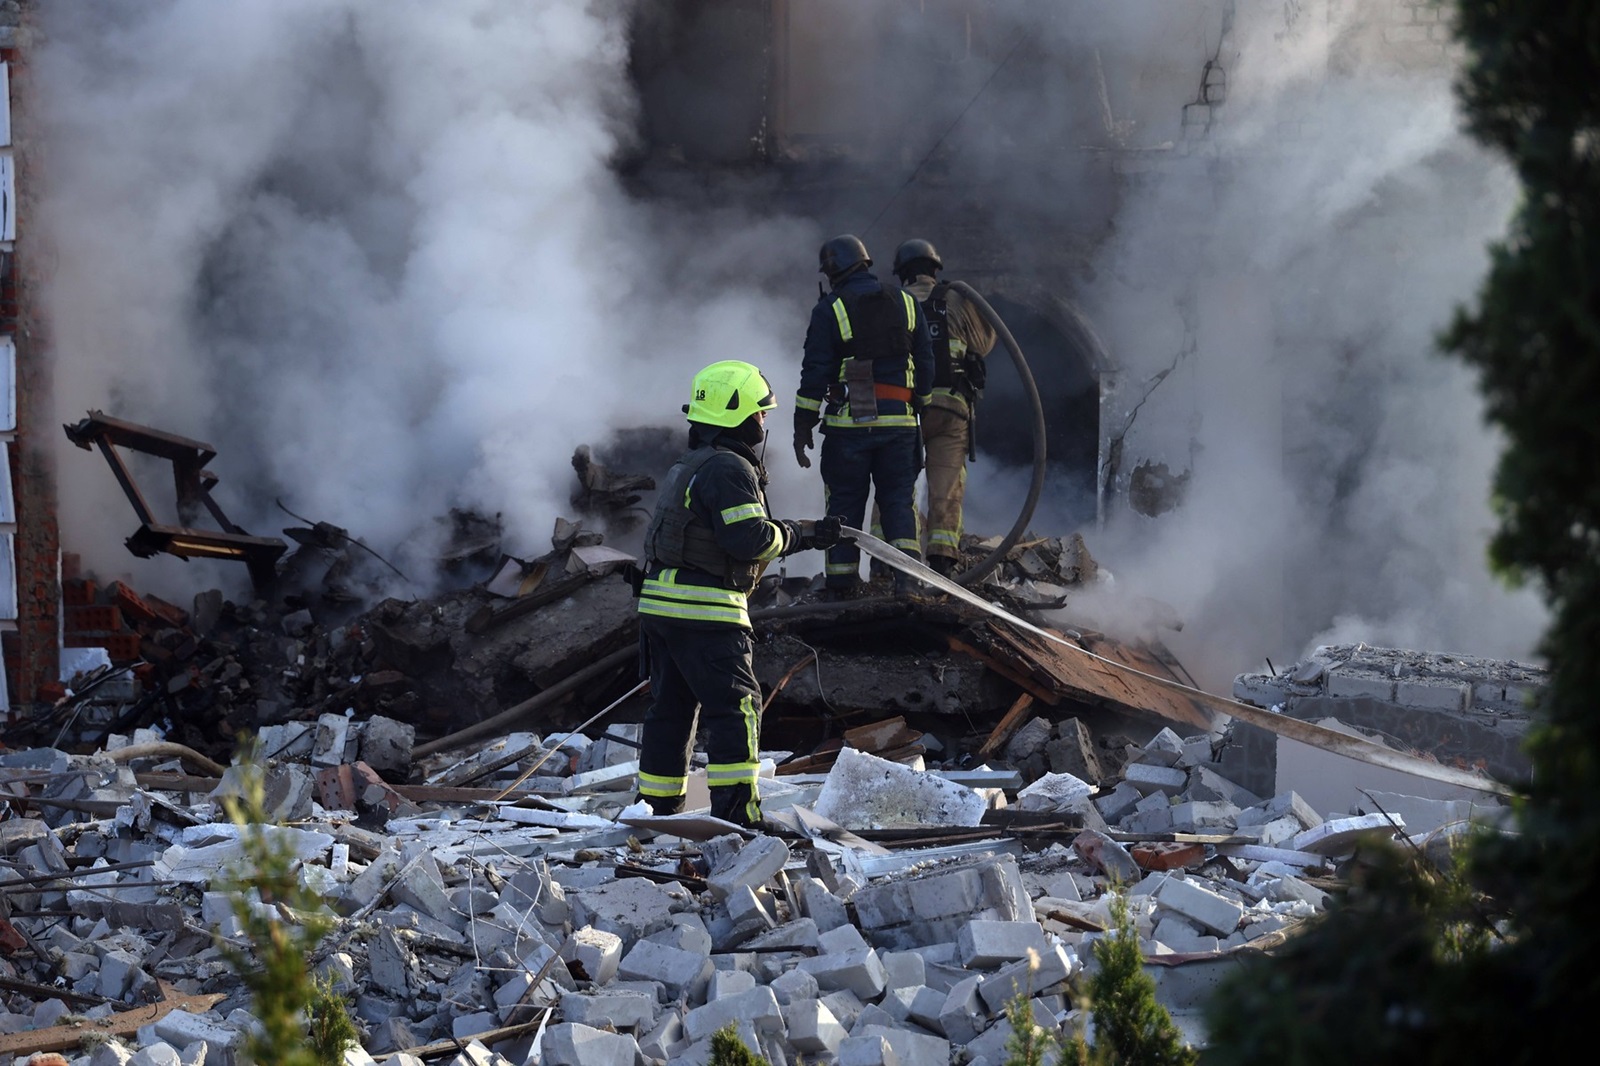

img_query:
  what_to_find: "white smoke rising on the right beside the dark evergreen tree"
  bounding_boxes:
[1043,5,1544,690]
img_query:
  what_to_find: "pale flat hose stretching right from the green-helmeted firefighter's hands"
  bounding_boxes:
[845,527,1515,795]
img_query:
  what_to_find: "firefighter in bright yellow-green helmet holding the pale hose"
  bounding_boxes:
[638,360,840,828]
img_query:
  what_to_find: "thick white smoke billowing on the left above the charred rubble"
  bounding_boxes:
[35,0,814,594]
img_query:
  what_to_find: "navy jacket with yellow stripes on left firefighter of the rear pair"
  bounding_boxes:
[795,271,933,429]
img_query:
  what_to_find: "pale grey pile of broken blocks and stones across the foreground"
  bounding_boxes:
[0,704,1504,1066]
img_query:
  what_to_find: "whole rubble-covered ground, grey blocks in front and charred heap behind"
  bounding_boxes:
[9,450,1542,1066]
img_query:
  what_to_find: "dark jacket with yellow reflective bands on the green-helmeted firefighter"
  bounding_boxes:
[638,434,800,629]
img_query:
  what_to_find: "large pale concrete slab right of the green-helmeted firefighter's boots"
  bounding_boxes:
[813,747,987,829]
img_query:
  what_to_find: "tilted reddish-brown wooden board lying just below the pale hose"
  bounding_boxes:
[971,621,1211,730]
